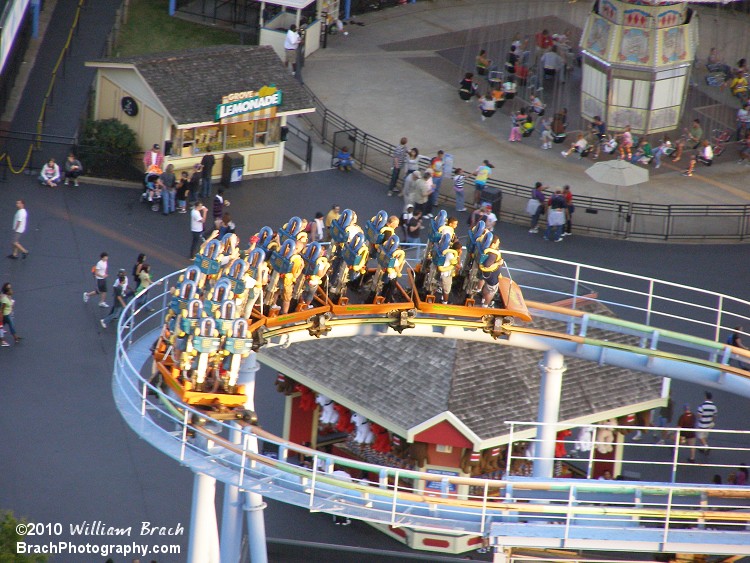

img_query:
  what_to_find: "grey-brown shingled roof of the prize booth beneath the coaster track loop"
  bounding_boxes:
[259,307,662,448]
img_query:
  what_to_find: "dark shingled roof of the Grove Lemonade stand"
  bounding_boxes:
[89,45,315,125]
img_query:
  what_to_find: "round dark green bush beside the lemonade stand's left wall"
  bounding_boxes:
[79,119,141,179]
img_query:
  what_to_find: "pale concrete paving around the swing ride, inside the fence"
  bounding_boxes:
[304,0,750,204]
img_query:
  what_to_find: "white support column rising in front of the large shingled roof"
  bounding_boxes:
[532,350,565,479]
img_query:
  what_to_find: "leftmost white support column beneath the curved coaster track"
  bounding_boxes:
[187,473,219,563]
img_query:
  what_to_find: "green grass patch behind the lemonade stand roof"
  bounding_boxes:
[115,0,240,57]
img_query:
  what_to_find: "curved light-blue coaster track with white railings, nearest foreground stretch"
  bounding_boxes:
[113,272,750,554]
